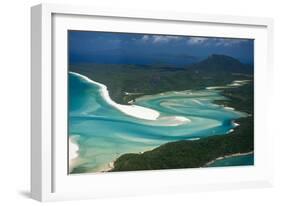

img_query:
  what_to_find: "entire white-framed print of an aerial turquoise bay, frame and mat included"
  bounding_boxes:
[31,4,273,201]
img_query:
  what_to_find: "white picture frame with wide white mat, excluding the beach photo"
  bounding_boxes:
[31,4,273,201]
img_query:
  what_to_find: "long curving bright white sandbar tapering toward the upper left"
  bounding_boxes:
[70,72,160,120]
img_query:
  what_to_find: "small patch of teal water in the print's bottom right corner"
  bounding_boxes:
[208,154,254,167]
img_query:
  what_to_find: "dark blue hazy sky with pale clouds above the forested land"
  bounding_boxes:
[68,31,254,66]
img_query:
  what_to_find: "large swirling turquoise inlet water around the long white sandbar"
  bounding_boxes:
[69,73,246,172]
